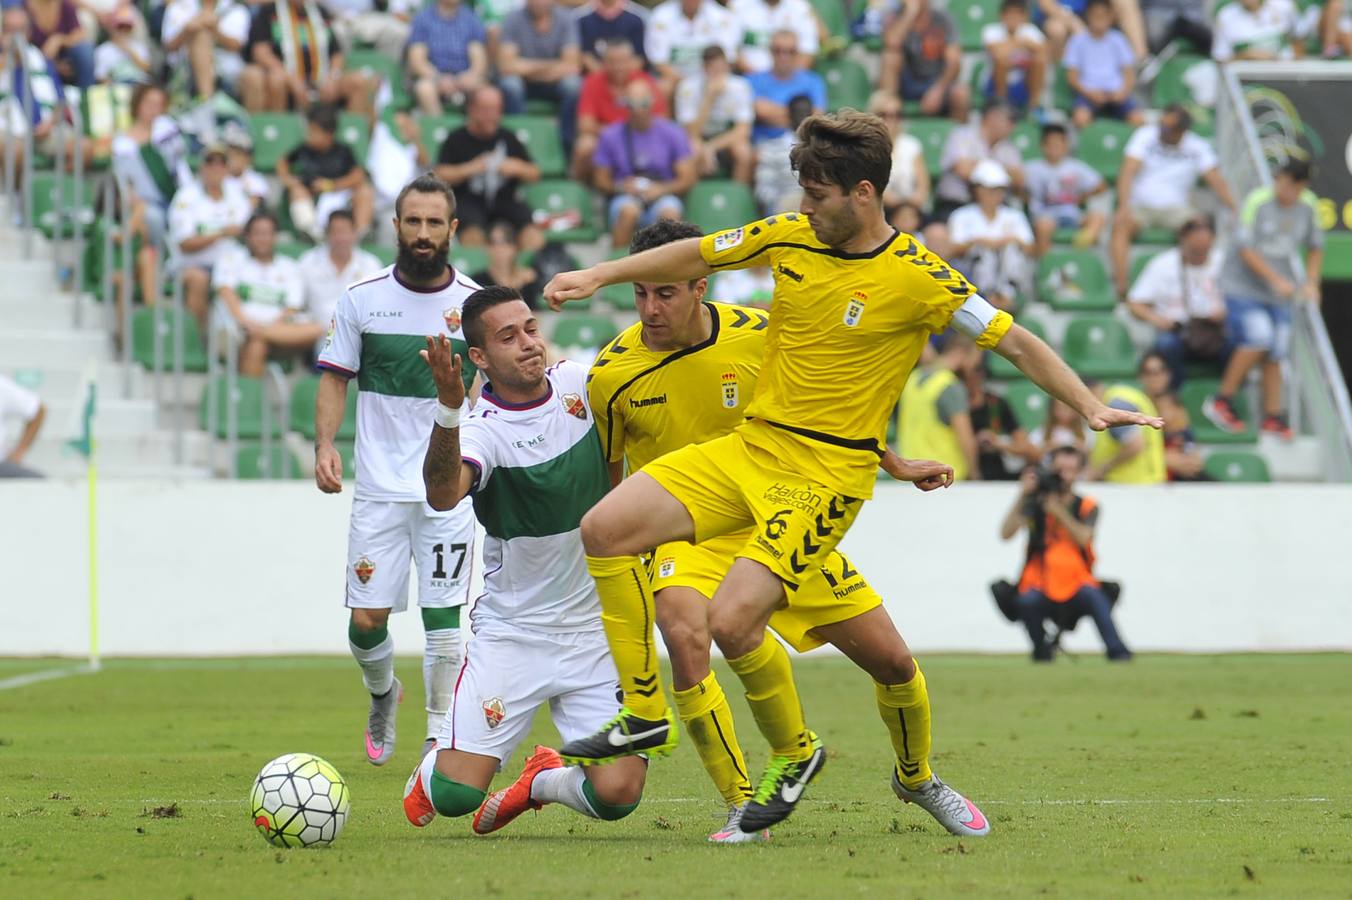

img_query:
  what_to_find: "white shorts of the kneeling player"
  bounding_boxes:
[437,626,621,769]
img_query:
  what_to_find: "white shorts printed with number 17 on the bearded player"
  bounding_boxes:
[347,499,475,612]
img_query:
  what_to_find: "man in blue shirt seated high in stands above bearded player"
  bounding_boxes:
[407,0,488,116]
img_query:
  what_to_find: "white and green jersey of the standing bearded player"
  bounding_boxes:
[319,266,479,503]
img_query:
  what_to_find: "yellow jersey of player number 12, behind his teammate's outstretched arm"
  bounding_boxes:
[587,303,769,472]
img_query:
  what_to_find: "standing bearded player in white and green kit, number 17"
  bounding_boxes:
[315,174,479,766]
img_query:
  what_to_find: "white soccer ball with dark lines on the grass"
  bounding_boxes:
[249,753,347,847]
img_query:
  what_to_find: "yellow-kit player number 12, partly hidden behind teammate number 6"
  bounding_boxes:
[587,220,952,843]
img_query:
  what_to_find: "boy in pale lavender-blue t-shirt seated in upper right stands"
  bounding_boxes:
[1061,0,1145,128]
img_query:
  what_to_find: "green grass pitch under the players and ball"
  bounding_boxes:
[0,654,1352,900]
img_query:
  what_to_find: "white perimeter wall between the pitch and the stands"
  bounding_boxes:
[0,481,1352,655]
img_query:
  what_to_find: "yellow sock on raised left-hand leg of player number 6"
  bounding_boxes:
[587,557,667,719]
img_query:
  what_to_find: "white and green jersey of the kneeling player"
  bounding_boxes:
[460,359,610,631]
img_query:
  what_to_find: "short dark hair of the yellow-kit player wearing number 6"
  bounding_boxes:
[788,107,892,200]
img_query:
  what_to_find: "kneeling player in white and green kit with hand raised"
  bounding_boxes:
[404,288,648,834]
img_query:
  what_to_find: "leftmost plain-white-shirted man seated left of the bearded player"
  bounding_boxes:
[169,145,253,327]
